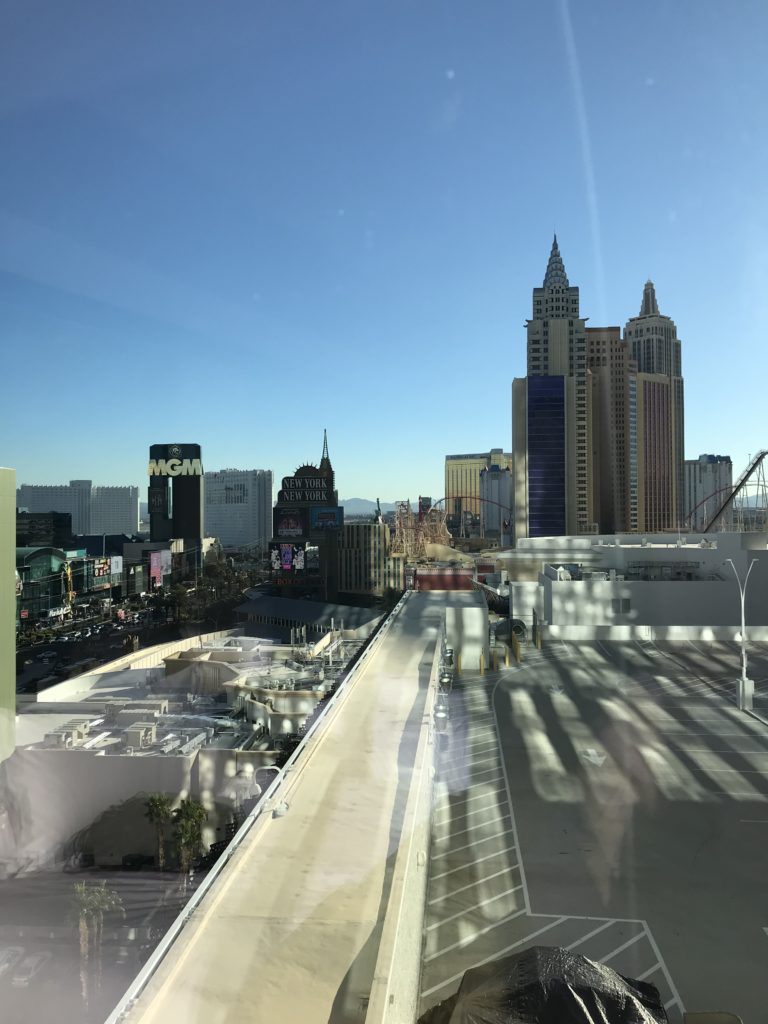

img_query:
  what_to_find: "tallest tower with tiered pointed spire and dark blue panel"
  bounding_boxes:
[512,236,596,538]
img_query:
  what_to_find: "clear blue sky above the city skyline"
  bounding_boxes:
[0,0,768,501]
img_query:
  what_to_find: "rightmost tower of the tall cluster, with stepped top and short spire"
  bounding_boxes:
[624,281,685,532]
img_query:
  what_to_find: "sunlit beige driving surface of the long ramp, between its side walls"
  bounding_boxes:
[121,594,444,1024]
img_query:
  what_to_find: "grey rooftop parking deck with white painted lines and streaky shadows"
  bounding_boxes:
[421,641,768,1024]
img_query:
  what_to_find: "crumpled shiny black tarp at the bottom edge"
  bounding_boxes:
[419,946,668,1024]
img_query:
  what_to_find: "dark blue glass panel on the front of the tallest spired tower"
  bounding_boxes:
[527,377,566,537]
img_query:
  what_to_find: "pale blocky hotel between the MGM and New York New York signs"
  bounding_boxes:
[204,469,272,551]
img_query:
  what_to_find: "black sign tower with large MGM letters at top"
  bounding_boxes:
[148,444,204,562]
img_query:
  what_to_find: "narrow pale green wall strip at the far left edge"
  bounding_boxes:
[0,469,16,761]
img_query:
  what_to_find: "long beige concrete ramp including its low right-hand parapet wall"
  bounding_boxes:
[110,592,455,1024]
